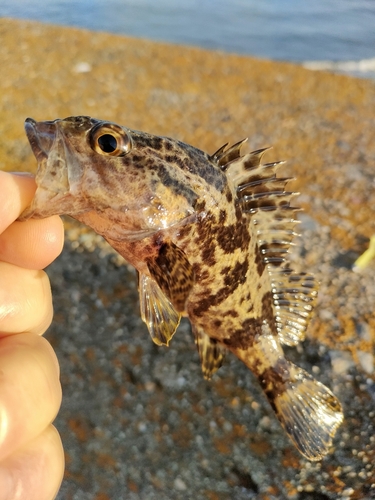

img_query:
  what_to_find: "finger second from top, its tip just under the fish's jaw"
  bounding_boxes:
[0,216,64,269]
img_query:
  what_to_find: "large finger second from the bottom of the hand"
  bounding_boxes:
[0,334,61,460]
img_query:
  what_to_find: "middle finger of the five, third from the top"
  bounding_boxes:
[0,262,53,336]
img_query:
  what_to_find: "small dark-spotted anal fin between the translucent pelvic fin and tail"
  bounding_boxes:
[192,326,225,380]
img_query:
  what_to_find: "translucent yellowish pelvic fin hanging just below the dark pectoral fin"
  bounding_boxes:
[138,273,181,345]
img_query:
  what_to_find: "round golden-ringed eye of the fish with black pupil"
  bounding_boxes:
[88,123,132,156]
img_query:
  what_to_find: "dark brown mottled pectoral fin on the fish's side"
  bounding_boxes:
[147,242,194,313]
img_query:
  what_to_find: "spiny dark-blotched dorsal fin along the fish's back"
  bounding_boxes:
[221,145,317,345]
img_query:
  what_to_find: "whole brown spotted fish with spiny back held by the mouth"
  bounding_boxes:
[21,116,343,460]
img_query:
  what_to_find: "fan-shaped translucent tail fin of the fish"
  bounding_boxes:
[266,362,343,461]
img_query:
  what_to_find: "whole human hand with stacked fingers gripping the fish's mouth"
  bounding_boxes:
[0,171,64,500]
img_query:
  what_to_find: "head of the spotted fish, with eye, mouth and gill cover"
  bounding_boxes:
[20,116,197,240]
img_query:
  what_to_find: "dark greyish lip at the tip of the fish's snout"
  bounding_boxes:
[25,118,56,163]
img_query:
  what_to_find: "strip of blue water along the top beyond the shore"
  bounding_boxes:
[0,0,375,78]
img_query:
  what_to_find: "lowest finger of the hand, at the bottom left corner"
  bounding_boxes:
[0,425,64,500]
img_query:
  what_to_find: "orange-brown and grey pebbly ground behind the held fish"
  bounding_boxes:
[0,19,375,500]
